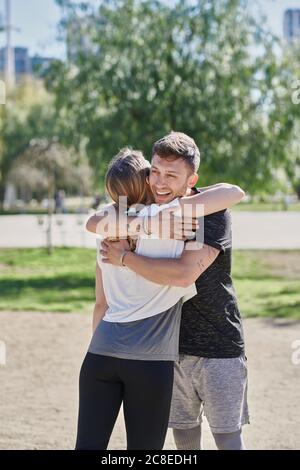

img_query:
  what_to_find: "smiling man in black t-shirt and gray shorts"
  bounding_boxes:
[87,132,249,450]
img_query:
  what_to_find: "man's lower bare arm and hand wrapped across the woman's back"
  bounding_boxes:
[101,241,220,287]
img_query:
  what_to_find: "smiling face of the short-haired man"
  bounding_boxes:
[149,154,198,204]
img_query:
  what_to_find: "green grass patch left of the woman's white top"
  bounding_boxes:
[0,248,95,312]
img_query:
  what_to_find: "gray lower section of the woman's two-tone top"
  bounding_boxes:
[88,299,182,361]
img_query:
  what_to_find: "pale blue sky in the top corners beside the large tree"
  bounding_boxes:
[0,0,300,58]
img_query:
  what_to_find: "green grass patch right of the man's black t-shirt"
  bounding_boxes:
[233,250,300,320]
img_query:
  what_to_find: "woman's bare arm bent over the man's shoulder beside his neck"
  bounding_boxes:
[180,183,245,217]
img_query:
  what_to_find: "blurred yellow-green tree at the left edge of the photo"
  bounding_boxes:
[0,80,90,207]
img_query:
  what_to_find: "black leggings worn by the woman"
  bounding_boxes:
[76,353,174,450]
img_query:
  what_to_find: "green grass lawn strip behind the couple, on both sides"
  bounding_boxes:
[0,248,300,319]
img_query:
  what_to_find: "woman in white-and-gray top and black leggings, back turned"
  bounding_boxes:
[76,149,242,450]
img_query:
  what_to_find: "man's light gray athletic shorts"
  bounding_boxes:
[169,354,249,434]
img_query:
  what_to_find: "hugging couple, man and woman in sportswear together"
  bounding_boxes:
[76,132,249,450]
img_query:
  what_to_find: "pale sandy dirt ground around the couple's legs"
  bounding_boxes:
[0,312,300,449]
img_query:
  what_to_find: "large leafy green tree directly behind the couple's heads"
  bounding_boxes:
[47,0,300,192]
